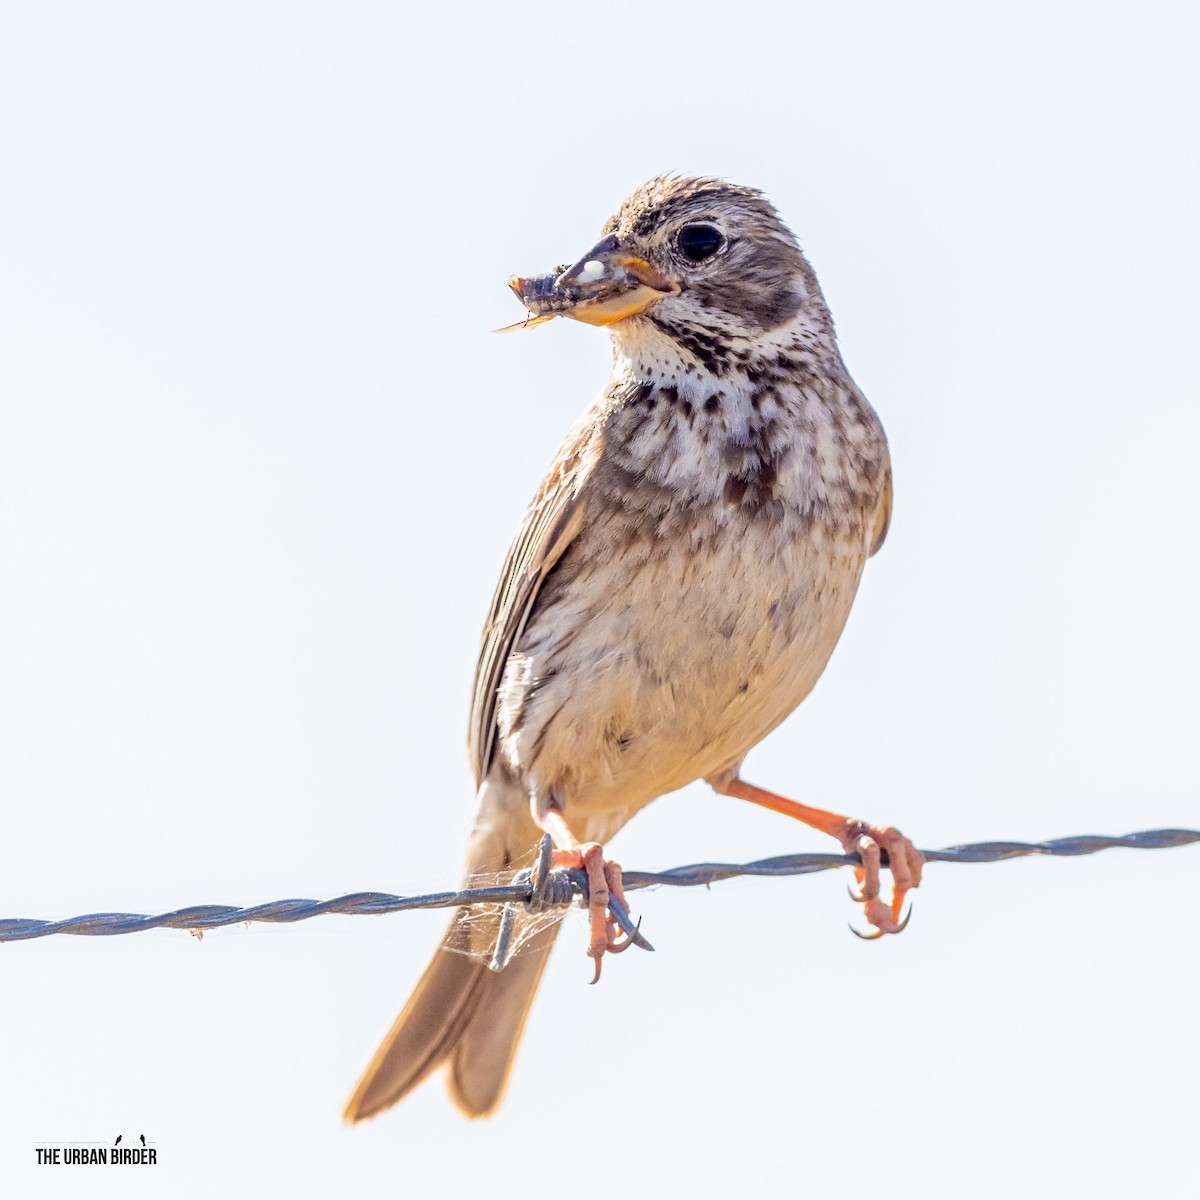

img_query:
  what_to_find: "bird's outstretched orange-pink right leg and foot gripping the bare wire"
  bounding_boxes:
[713,778,925,938]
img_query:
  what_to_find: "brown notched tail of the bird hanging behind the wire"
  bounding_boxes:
[346,785,559,1122]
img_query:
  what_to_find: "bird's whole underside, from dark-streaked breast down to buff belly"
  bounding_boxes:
[489,369,887,836]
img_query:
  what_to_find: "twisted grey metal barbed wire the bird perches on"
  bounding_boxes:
[0,829,1200,945]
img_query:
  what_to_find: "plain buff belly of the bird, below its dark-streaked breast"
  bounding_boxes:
[499,494,865,835]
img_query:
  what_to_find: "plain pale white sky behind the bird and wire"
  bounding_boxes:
[0,0,1200,1200]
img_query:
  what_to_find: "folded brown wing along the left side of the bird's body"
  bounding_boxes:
[467,413,601,787]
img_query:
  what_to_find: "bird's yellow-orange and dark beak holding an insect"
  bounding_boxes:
[509,238,679,325]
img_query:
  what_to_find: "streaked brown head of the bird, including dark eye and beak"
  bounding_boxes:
[509,176,832,360]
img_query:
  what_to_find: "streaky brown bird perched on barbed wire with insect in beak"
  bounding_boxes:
[344,174,923,1122]
